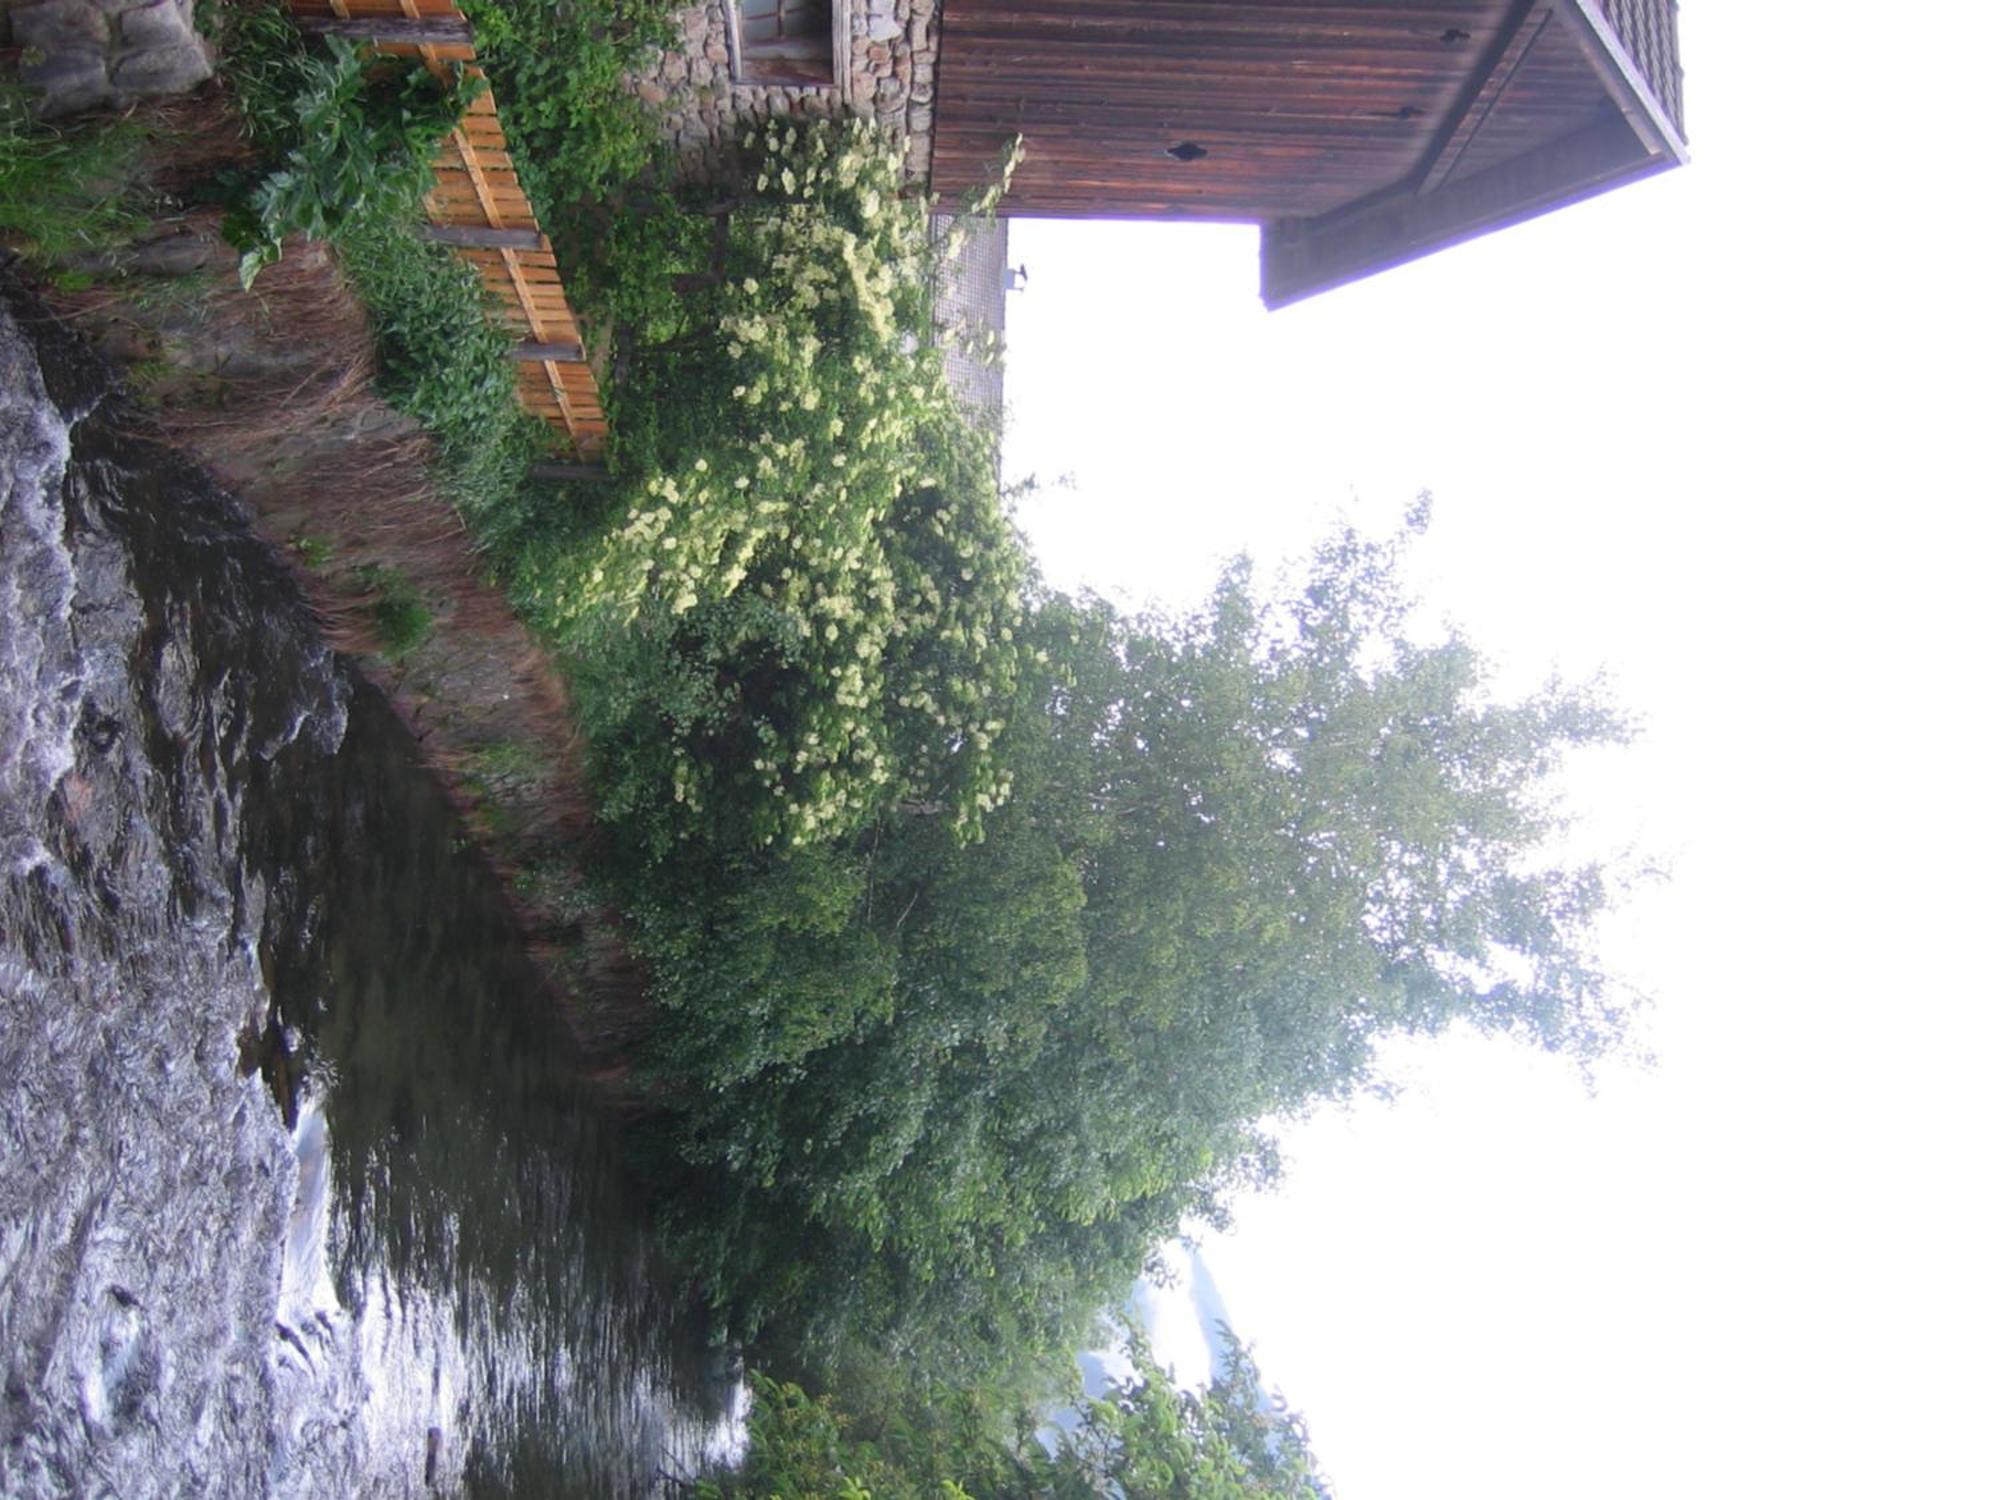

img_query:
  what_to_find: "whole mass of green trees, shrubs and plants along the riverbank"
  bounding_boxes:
[7,14,1626,1494]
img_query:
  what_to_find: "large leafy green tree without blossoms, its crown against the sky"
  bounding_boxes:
[652,516,1624,1372]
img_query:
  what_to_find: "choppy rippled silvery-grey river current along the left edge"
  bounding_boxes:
[0,262,348,1496]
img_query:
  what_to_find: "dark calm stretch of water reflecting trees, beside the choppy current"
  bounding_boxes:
[258,692,736,1496]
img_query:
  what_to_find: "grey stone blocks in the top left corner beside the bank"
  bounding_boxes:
[0,0,212,116]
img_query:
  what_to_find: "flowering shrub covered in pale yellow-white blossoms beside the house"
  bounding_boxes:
[542,122,1026,850]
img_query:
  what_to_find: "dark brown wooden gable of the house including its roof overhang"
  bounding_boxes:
[932,0,1686,306]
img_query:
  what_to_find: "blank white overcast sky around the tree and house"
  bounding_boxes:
[1008,11,2000,1500]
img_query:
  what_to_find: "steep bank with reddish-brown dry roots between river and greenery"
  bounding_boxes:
[17,156,642,1100]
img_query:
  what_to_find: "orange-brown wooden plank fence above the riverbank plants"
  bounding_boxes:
[290,0,606,458]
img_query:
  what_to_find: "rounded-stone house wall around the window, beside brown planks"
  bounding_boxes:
[638,0,940,182]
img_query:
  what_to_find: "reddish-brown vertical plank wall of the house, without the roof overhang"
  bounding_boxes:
[932,0,1508,222]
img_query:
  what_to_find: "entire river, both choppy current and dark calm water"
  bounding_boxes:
[0,268,740,1498]
